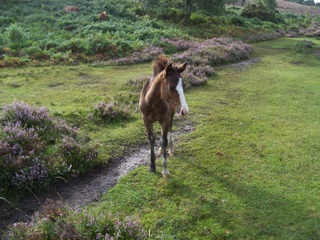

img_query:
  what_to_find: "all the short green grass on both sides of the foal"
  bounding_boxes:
[0,38,320,239]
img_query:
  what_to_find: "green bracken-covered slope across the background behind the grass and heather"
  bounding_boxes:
[0,0,317,67]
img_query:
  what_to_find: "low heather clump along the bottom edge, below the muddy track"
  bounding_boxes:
[4,200,147,240]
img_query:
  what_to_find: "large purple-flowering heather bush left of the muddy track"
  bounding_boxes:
[0,102,98,191]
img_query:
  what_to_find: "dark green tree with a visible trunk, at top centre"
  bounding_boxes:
[140,0,225,25]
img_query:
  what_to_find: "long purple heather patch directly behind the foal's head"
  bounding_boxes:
[106,38,253,86]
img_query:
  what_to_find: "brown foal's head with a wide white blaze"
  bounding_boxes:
[161,63,189,116]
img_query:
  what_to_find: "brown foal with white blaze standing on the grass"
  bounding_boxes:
[139,54,189,177]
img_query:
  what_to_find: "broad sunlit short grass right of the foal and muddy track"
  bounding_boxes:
[95,39,320,239]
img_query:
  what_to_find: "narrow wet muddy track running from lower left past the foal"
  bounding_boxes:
[0,121,193,233]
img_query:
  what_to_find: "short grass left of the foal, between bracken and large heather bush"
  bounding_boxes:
[0,63,152,162]
